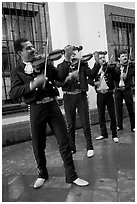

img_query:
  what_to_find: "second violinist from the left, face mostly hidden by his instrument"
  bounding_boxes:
[57,52,99,157]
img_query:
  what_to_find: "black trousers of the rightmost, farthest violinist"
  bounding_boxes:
[114,89,135,130]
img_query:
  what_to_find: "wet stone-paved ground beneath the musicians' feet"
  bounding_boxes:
[2,118,135,202]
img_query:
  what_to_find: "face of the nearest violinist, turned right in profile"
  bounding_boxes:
[19,41,35,62]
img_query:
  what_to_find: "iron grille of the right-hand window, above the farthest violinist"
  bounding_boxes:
[110,14,135,61]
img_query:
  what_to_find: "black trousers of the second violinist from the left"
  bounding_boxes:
[63,92,93,150]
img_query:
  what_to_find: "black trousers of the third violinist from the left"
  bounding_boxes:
[97,92,117,137]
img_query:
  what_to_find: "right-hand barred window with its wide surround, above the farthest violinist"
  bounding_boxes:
[104,5,135,61]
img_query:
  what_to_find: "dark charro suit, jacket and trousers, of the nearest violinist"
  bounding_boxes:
[11,61,77,183]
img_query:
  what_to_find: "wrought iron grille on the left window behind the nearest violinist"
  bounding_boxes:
[2,2,51,102]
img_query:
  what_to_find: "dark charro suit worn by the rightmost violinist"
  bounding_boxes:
[114,63,135,130]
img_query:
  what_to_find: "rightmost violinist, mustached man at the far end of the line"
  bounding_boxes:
[114,50,135,132]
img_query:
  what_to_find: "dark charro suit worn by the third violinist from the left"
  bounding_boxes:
[89,63,119,138]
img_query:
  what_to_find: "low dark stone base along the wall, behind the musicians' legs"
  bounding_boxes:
[2,106,128,146]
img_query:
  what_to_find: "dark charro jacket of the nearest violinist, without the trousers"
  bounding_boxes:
[11,58,70,104]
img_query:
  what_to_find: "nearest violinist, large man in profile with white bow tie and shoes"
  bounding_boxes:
[11,38,88,188]
